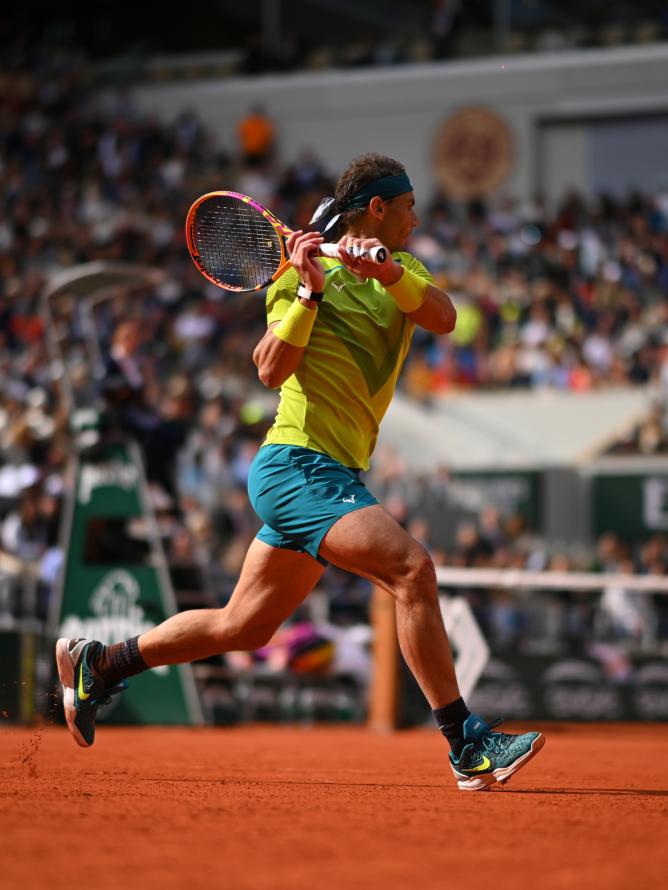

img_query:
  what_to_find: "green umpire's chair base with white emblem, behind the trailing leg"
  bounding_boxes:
[53,443,202,724]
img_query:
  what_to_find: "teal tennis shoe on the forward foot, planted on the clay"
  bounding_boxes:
[450,714,545,791]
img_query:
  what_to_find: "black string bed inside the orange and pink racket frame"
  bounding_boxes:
[192,196,282,290]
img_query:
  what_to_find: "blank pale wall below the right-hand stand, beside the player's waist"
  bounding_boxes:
[379,387,652,472]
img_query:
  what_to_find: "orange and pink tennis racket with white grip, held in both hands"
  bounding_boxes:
[186,192,387,291]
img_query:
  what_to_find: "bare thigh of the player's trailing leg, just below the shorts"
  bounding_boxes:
[224,538,324,628]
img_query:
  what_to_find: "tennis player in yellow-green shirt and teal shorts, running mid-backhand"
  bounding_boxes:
[56,154,544,790]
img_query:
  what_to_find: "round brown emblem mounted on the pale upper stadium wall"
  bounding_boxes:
[434,107,514,200]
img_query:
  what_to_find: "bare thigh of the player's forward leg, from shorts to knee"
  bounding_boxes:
[320,504,436,592]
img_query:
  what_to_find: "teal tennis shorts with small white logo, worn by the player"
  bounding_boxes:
[248,445,378,562]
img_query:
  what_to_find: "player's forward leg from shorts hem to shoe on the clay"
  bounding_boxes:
[319,505,545,791]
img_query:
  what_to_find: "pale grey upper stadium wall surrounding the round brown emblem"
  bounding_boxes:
[132,44,668,202]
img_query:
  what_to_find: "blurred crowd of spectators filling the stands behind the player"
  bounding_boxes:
[0,54,668,652]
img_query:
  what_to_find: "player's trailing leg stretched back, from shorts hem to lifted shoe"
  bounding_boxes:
[56,538,323,747]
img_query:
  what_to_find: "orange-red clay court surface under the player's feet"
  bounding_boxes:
[0,725,668,890]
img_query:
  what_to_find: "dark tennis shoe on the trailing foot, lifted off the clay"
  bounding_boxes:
[56,638,128,748]
